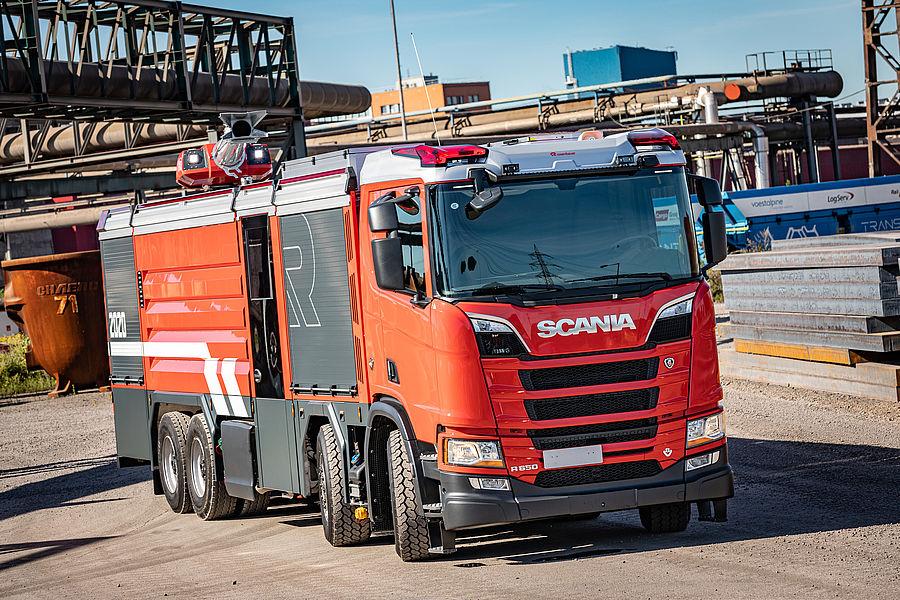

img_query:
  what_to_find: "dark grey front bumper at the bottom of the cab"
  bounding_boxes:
[440,446,734,531]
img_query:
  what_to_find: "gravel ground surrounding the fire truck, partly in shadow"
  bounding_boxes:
[0,379,900,599]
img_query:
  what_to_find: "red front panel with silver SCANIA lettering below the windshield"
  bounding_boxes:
[459,283,698,357]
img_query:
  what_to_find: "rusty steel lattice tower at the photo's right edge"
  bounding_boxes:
[862,0,900,177]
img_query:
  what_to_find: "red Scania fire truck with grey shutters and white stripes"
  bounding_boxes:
[99,130,733,560]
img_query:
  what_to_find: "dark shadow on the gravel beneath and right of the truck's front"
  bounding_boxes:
[440,438,900,568]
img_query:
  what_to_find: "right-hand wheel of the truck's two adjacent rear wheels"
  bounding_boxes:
[185,414,238,521]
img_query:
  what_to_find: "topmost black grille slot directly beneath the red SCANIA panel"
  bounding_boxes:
[519,356,659,391]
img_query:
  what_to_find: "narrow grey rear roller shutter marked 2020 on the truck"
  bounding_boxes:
[100,237,144,383]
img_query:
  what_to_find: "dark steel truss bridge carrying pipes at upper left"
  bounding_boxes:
[0,0,305,176]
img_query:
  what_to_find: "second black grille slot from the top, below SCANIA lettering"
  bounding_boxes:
[525,388,659,421]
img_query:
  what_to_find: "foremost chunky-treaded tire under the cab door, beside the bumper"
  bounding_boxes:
[387,429,429,562]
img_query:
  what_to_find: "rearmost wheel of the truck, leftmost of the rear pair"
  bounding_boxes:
[156,412,193,514]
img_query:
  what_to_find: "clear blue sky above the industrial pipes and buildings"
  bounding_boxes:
[222,0,863,100]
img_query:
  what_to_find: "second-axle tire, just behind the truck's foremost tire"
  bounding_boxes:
[316,425,372,546]
